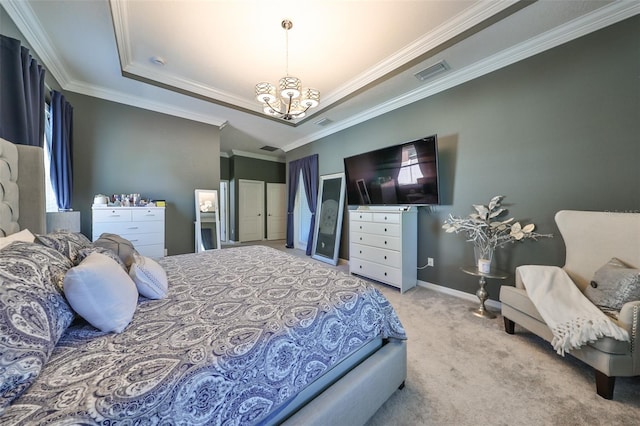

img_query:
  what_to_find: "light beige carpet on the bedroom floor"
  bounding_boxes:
[228,241,640,426]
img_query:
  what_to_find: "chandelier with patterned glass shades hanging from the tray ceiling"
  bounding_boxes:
[256,19,320,120]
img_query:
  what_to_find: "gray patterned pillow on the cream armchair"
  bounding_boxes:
[584,257,640,313]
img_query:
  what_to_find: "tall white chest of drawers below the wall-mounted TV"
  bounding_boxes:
[349,207,418,293]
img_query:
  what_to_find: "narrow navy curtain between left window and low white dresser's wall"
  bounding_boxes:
[49,90,73,211]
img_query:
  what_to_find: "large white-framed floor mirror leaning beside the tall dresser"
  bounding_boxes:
[311,173,345,265]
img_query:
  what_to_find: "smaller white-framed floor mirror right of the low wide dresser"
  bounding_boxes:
[195,189,222,253]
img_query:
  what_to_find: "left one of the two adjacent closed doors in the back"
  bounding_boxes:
[238,179,264,242]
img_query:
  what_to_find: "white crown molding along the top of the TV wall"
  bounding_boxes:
[282,1,640,152]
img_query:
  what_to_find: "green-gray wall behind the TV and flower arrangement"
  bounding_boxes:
[287,17,640,299]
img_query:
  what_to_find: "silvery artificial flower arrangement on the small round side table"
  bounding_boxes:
[442,195,553,272]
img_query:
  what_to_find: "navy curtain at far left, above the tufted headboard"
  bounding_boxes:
[0,35,45,147]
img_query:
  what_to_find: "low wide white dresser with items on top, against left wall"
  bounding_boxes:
[92,206,164,258]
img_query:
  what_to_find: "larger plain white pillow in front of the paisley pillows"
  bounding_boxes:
[64,252,138,333]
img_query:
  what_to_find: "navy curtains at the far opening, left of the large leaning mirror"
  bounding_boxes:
[287,154,318,256]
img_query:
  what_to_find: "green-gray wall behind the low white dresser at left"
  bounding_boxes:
[65,92,220,255]
